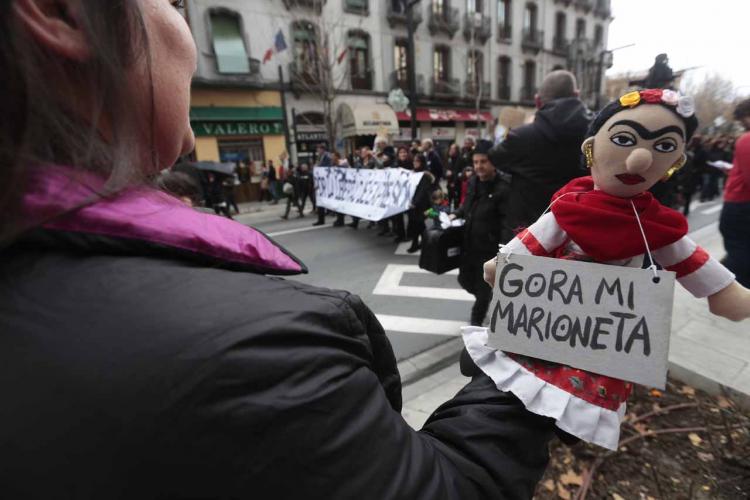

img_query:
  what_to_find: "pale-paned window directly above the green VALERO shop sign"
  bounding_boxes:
[209,9,250,74]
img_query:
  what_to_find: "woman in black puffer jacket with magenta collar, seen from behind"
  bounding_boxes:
[0,0,552,499]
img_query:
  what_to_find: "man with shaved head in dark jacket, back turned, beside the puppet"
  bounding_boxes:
[490,70,593,236]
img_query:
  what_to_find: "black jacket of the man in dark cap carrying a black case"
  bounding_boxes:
[454,173,512,262]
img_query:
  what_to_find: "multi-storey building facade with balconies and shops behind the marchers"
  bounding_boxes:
[187,0,611,161]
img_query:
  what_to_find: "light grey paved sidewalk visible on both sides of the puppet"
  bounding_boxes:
[406,223,750,429]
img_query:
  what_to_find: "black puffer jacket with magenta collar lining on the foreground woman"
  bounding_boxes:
[0,170,553,500]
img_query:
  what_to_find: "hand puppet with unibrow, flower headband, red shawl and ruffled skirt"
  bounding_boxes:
[463,89,750,449]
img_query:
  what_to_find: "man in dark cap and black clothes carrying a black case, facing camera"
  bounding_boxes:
[452,140,511,326]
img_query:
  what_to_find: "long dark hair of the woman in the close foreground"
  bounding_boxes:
[0,0,145,234]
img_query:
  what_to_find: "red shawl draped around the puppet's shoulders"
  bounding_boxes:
[551,177,688,262]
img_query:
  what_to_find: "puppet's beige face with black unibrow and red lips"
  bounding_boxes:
[584,104,685,198]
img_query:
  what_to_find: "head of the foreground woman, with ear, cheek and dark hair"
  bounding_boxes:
[0,0,195,243]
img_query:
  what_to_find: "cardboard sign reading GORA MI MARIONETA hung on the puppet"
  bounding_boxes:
[489,254,675,388]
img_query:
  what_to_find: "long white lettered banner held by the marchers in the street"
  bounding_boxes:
[313,167,424,221]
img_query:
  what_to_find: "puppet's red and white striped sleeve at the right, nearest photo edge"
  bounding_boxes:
[654,236,734,298]
